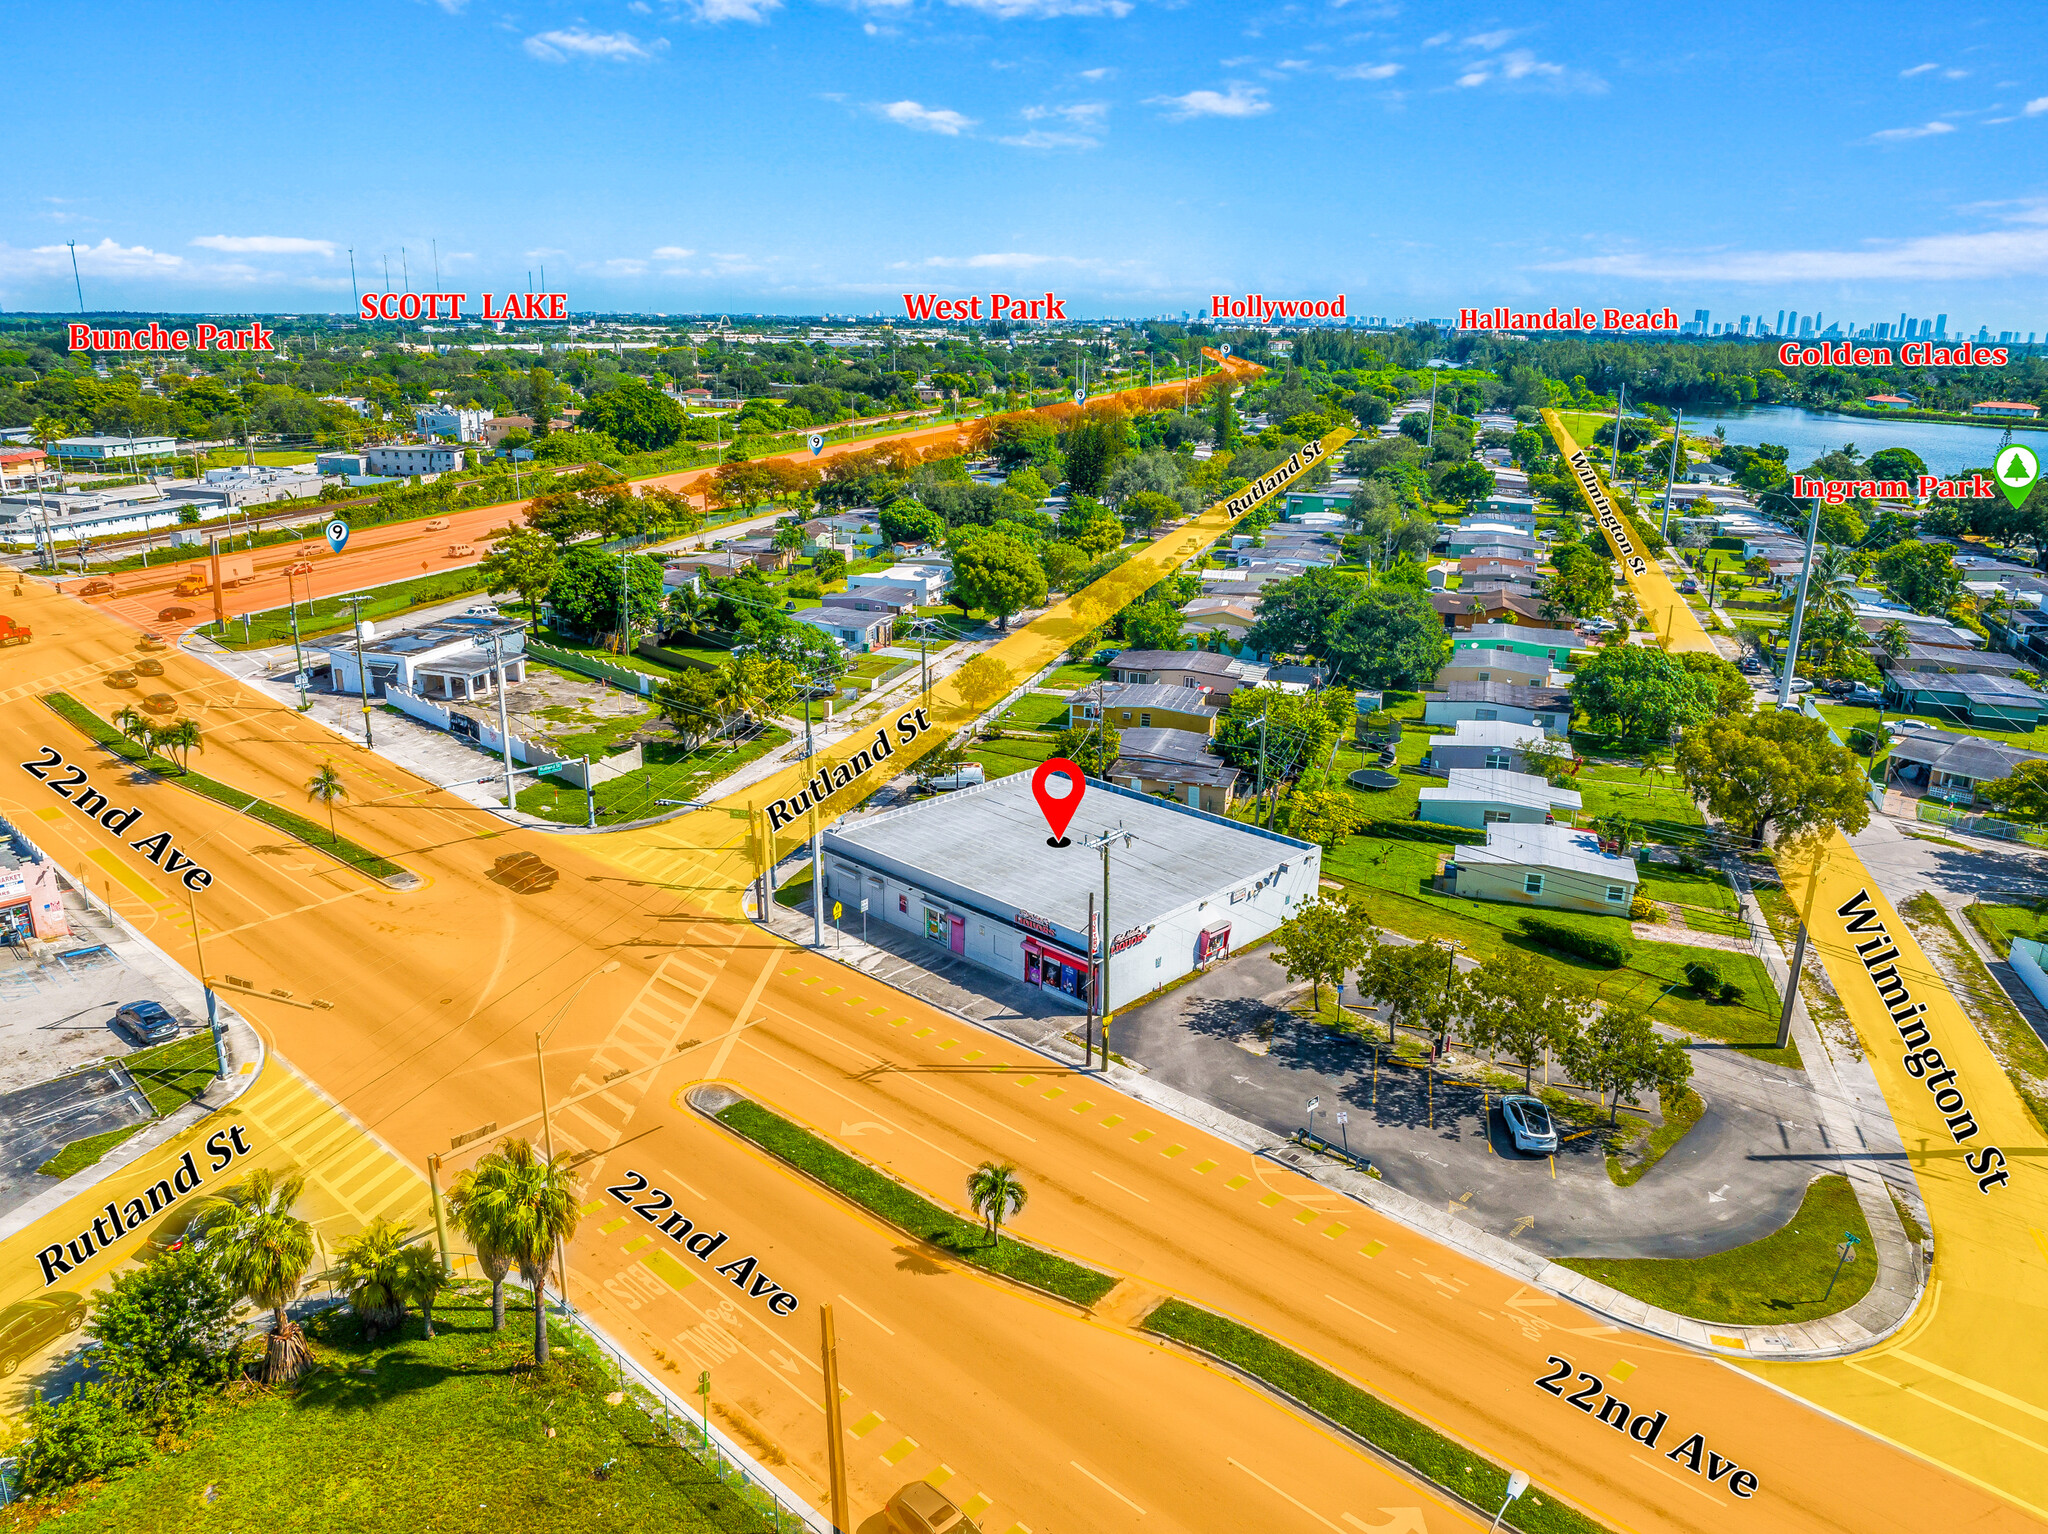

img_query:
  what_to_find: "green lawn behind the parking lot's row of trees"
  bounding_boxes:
[1323,836,1798,1067]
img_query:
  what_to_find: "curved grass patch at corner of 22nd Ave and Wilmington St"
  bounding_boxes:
[1556,1176,1878,1325]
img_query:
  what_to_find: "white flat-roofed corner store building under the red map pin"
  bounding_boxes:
[823,772,1323,1012]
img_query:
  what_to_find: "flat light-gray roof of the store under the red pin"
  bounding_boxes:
[825,772,1315,932]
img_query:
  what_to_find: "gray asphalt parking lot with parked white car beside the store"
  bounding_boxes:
[1112,950,1888,1258]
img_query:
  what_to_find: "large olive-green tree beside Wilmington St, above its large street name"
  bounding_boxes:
[1677,709,1870,846]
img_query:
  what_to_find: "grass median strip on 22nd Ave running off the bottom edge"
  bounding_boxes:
[1145,1301,1602,1534]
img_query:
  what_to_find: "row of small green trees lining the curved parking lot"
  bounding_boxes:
[1274,893,1692,1122]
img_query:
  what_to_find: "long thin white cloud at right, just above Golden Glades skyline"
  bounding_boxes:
[1538,205,2048,283]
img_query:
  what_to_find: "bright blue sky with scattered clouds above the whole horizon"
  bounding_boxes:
[12,0,2048,334]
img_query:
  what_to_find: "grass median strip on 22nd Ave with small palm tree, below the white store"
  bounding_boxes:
[719,1097,1116,1305]
